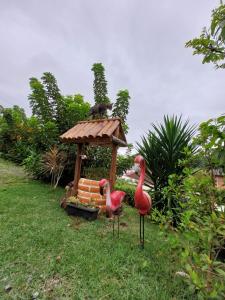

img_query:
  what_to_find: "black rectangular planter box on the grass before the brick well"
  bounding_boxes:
[66,203,99,221]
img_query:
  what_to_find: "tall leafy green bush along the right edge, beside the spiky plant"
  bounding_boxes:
[158,116,225,299]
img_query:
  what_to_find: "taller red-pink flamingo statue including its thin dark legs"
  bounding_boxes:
[134,155,152,249]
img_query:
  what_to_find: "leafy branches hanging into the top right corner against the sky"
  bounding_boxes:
[186,1,225,68]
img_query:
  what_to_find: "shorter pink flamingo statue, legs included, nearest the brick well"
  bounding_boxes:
[99,179,126,236]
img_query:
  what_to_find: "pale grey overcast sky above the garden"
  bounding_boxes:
[0,0,225,142]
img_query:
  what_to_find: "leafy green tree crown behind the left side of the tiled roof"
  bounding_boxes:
[29,72,90,134]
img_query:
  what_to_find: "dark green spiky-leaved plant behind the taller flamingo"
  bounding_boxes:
[137,116,195,210]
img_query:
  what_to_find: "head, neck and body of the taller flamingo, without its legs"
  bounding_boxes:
[134,155,152,216]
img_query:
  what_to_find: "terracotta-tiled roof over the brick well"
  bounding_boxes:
[60,118,127,147]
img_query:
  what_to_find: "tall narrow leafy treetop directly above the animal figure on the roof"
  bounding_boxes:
[91,63,110,104]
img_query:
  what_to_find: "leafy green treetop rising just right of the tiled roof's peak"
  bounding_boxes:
[112,90,130,133]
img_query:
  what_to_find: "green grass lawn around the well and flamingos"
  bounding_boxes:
[0,160,194,300]
